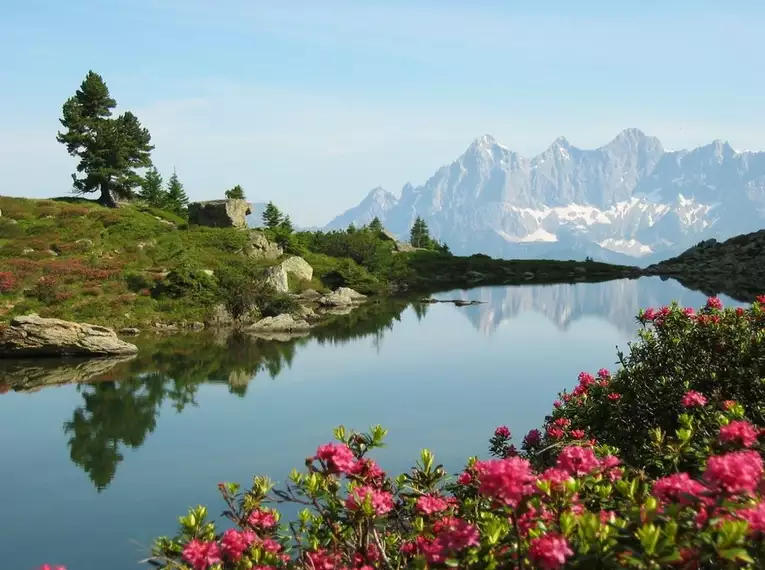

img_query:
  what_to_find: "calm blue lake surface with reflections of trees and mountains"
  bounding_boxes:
[0,278,734,570]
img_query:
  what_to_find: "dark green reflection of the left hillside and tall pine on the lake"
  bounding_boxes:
[0,302,406,491]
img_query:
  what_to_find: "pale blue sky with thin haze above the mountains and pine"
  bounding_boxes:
[0,0,765,225]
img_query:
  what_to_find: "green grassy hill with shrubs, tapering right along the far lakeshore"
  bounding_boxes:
[0,197,638,327]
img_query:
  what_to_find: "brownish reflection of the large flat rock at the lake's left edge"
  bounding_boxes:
[0,356,135,392]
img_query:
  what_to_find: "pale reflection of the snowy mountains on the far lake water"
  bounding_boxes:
[442,277,748,335]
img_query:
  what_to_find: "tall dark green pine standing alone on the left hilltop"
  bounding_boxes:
[56,71,154,207]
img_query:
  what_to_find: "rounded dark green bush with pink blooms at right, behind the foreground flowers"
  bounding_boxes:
[536,297,765,476]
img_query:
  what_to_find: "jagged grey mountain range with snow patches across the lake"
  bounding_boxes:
[327,129,765,265]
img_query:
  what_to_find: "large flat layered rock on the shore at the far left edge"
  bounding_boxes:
[0,314,138,358]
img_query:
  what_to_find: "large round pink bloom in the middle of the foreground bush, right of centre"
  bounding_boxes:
[475,457,535,507]
